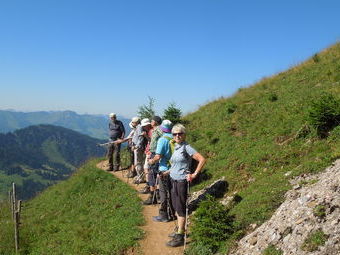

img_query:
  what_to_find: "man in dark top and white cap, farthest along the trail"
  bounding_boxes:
[107,113,125,171]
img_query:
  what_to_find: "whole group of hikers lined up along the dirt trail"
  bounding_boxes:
[107,113,206,247]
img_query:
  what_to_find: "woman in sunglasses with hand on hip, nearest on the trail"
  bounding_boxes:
[167,124,206,247]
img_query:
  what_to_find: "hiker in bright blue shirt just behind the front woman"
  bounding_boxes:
[149,120,174,222]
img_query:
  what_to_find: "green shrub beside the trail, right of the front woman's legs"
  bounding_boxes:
[191,196,234,252]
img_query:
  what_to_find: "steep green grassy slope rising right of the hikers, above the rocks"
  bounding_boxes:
[184,43,340,252]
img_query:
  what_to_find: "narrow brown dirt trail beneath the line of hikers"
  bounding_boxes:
[97,161,183,255]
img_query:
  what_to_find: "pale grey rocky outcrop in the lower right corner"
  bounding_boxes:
[231,160,340,255]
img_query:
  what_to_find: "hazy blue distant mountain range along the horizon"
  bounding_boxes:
[0,110,130,139]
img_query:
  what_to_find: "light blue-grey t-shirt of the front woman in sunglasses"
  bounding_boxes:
[170,142,197,180]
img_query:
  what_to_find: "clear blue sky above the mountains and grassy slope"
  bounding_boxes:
[0,0,340,117]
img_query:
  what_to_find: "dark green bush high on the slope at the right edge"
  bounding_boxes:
[308,93,340,138]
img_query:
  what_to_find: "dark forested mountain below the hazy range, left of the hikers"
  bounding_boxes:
[0,125,105,199]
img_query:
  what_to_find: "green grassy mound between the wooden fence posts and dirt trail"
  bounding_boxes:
[0,160,143,254]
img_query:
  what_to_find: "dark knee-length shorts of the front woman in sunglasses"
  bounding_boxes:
[171,179,188,217]
